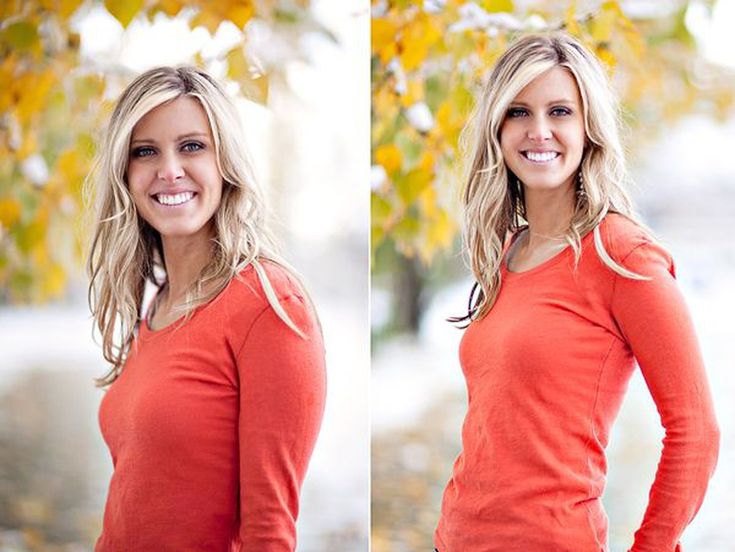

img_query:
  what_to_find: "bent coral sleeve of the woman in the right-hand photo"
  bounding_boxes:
[612,241,720,552]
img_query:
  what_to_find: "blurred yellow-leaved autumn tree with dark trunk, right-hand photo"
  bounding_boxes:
[371,0,733,331]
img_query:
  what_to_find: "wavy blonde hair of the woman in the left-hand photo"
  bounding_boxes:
[85,66,303,387]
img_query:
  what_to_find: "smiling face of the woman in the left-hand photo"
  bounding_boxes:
[127,96,222,241]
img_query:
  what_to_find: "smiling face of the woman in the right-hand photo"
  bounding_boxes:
[500,66,585,192]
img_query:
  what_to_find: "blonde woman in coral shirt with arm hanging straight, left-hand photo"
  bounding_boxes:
[88,67,325,552]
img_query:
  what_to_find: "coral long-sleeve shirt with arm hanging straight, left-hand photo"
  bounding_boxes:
[95,262,325,552]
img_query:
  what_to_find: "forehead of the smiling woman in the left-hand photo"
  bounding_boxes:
[132,96,211,140]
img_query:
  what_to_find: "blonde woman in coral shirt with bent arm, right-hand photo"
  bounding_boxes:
[435,33,719,552]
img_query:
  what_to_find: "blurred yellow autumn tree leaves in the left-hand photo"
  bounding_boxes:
[0,0,328,303]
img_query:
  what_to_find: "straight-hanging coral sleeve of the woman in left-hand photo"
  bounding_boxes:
[236,295,326,552]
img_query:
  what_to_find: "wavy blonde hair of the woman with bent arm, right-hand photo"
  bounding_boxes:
[450,32,653,323]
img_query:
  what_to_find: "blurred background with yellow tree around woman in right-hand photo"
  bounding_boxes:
[371,0,735,552]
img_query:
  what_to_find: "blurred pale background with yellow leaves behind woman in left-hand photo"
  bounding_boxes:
[0,0,370,552]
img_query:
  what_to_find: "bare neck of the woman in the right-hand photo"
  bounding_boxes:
[524,180,575,247]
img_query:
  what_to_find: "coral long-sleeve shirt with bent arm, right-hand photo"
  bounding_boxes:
[435,214,719,552]
